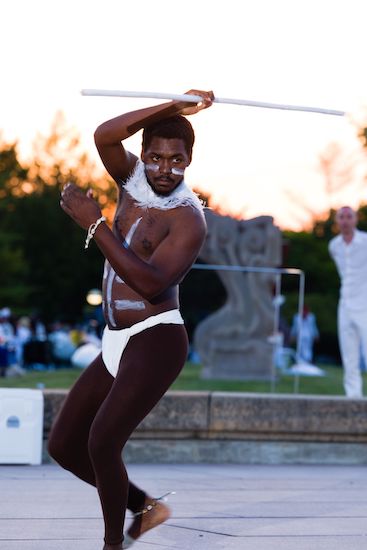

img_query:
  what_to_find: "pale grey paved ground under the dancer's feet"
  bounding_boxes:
[0,464,367,550]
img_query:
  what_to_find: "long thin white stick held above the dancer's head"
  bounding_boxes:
[81,89,346,116]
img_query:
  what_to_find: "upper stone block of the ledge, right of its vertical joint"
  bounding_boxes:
[209,392,367,442]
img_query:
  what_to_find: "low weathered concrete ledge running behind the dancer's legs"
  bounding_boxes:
[44,390,367,464]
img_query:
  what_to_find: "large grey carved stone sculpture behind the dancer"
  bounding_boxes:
[194,209,282,380]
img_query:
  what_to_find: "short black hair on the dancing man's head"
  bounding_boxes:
[142,115,195,158]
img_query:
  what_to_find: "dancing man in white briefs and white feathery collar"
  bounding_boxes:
[49,90,214,550]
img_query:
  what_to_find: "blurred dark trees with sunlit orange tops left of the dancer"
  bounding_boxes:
[0,122,113,321]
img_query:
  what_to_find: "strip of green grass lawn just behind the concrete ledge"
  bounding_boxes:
[0,363,360,395]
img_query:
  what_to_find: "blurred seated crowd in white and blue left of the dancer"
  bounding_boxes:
[0,307,101,377]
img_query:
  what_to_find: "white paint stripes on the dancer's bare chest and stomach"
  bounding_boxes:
[103,218,145,327]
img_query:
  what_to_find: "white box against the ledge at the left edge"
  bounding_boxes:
[0,388,43,464]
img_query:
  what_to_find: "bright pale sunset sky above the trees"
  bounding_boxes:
[0,0,367,229]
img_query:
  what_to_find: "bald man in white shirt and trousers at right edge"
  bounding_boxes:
[329,206,367,398]
